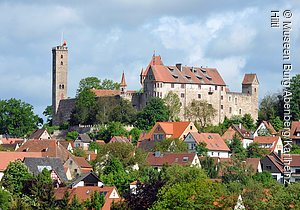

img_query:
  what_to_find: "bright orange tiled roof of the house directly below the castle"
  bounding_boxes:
[144,122,191,139]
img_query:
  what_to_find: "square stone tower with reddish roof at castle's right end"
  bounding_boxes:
[242,74,259,120]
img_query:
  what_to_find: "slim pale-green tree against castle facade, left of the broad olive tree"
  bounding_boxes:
[164,91,180,121]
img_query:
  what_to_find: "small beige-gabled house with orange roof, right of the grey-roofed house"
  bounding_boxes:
[64,155,93,178]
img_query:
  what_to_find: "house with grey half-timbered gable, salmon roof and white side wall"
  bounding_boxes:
[184,132,230,158]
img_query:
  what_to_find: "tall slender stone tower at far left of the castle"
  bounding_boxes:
[52,41,68,116]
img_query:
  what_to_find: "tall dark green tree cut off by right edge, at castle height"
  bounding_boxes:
[289,74,300,121]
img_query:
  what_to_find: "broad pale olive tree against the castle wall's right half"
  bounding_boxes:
[185,100,217,128]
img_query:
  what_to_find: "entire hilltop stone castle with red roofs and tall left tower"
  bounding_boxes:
[52,43,259,125]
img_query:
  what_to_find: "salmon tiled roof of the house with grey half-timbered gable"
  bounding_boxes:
[190,132,230,151]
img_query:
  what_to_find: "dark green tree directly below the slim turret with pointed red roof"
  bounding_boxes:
[109,98,136,125]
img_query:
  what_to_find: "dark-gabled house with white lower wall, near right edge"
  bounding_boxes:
[261,153,284,183]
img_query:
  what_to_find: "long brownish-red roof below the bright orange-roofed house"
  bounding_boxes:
[146,152,196,166]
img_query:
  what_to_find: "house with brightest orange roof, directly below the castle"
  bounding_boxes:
[137,122,198,152]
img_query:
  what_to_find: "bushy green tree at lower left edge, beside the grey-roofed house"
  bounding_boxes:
[1,160,32,195]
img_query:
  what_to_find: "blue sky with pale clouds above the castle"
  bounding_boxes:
[0,0,300,116]
